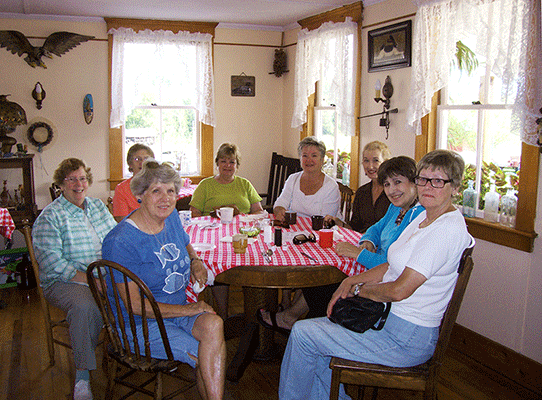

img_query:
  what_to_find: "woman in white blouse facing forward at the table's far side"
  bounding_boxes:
[273,136,341,221]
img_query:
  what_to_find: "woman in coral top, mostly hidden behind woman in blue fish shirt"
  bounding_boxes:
[113,143,154,222]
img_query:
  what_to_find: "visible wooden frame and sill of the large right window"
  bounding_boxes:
[415,91,540,253]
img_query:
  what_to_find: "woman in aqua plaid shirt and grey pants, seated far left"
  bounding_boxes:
[32,158,116,400]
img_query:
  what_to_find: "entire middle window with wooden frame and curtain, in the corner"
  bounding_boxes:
[292,2,362,188]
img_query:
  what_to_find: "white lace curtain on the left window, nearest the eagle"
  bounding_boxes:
[108,28,215,128]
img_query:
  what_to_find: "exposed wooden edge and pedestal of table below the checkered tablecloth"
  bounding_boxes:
[215,265,346,368]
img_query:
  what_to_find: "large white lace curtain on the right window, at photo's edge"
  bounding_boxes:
[407,0,542,145]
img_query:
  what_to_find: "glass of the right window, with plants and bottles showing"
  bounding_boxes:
[437,44,521,217]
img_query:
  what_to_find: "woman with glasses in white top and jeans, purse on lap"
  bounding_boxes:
[279,150,472,399]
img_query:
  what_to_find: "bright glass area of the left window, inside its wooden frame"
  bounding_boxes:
[123,39,201,176]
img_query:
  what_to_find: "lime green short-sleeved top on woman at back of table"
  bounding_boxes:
[190,176,262,215]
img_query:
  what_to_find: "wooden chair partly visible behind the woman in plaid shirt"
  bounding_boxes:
[23,220,71,365]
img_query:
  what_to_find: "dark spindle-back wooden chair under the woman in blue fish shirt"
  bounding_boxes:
[87,260,196,400]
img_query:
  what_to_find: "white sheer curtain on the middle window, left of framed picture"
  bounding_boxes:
[292,17,358,135]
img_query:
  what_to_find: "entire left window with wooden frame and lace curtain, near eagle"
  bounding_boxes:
[106,19,217,189]
